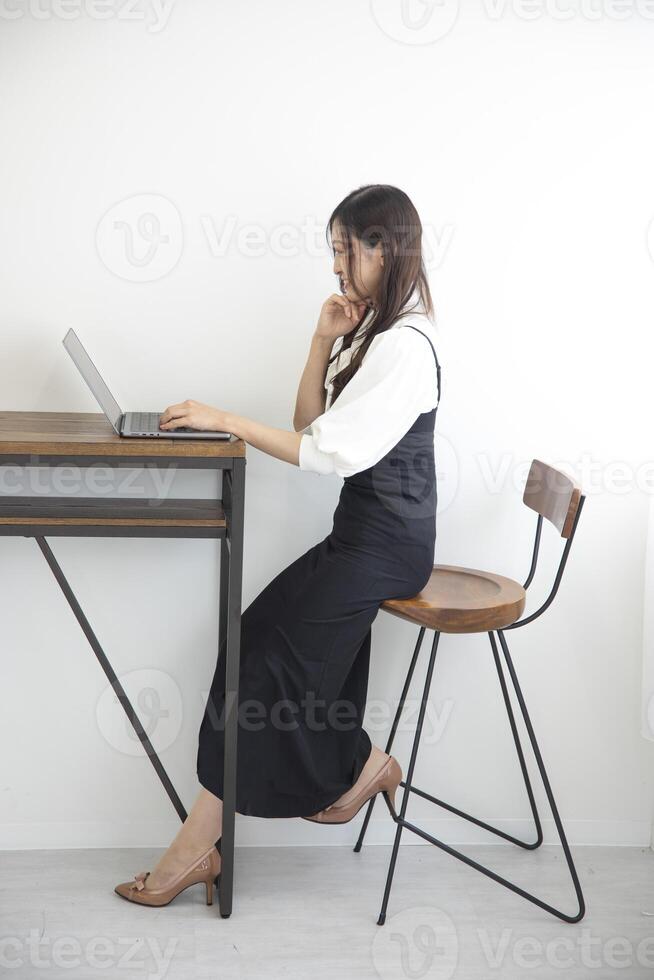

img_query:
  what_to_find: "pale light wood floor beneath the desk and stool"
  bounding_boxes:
[0,845,654,980]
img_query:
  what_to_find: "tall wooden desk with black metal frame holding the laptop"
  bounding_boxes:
[0,412,245,918]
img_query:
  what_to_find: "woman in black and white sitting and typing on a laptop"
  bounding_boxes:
[115,184,440,906]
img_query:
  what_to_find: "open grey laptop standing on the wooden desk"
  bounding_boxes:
[62,328,231,439]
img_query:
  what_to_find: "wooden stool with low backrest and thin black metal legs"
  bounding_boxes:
[354,459,585,925]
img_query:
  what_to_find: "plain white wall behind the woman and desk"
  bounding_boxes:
[0,0,654,848]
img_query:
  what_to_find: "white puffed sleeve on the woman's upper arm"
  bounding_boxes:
[299,327,438,477]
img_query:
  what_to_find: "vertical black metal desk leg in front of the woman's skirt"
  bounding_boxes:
[219,458,245,919]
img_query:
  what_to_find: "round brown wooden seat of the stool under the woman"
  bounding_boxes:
[381,565,527,633]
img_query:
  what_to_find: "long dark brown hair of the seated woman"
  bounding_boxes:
[326,184,434,405]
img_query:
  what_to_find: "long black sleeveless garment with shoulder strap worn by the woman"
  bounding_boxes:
[197,324,441,817]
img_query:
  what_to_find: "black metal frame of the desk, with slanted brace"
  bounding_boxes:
[0,451,246,918]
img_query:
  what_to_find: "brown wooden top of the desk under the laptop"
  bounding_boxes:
[0,412,246,458]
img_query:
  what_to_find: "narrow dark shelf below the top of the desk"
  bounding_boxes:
[0,496,227,538]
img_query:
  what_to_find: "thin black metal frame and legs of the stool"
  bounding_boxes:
[354,494,586,925]
